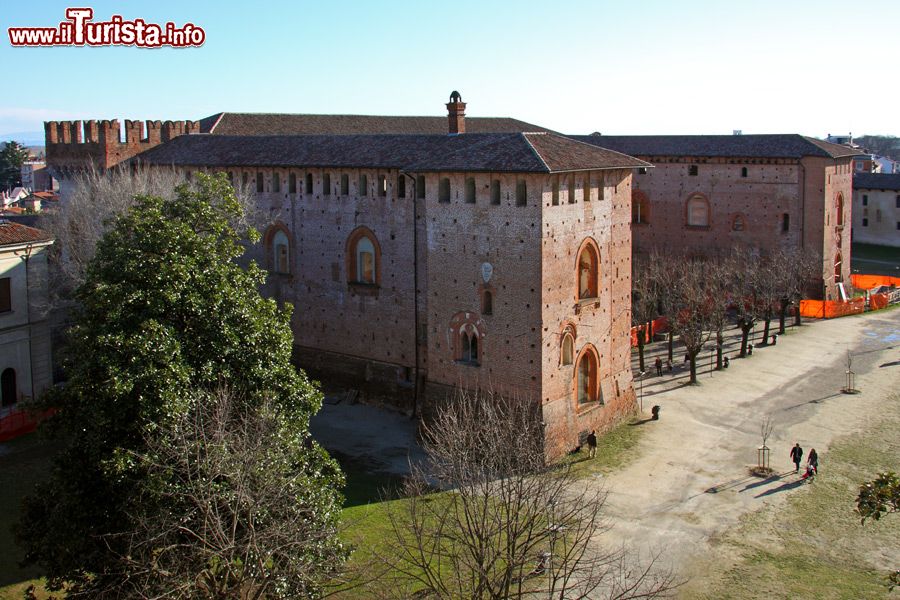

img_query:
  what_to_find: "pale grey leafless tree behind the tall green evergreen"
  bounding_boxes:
[41,167,265,303]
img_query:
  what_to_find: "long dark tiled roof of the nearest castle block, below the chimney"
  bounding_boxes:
[133,133,649,173]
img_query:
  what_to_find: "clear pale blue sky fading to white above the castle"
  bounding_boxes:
[0,0,900,137]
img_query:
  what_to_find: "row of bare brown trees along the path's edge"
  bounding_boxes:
[631,248,820,383]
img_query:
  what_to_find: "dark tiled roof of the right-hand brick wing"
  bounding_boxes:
[570,133,862,158]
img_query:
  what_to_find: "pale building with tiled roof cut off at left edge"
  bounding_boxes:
[0,220,53,414]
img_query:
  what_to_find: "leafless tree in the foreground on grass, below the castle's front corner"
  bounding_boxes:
[384,392,673,600]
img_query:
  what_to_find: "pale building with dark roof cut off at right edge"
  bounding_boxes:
[853,173,900,247]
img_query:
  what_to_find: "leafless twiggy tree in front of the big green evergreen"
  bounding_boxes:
[91,390,347,600]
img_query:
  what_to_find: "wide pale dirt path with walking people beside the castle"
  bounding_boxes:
[598,309,900,571]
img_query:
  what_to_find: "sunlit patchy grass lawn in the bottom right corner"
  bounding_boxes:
[681,396,900,600]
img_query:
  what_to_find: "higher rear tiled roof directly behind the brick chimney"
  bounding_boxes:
[200,112,547,135]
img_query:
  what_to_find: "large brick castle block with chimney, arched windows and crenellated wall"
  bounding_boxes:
[46,93,650,456]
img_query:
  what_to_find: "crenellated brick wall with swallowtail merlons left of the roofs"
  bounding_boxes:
[44,119,200,171]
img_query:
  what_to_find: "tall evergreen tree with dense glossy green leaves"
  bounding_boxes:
[17,174,344,597]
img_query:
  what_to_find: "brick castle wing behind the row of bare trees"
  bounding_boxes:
[573,134,859,299]
